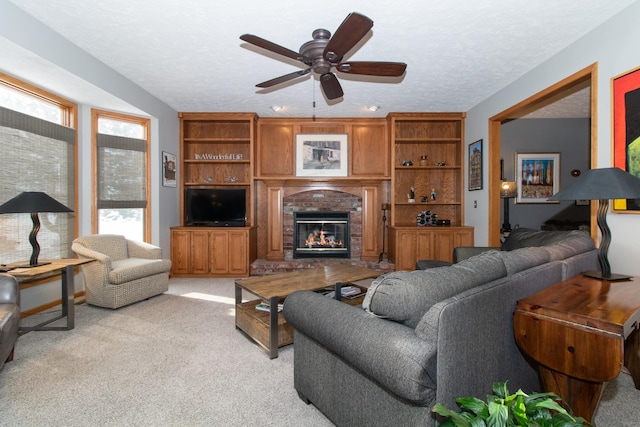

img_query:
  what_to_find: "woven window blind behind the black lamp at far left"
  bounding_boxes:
[0,107,76,264]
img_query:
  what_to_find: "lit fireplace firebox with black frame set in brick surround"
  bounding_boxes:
[293,211,351,258]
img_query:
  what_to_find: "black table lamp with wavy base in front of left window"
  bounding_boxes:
[0,191,73,268]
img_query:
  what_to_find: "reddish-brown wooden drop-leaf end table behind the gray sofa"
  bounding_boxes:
[513,275,640,422]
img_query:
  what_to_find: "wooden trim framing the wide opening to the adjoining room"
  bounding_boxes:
[488,64,597,246]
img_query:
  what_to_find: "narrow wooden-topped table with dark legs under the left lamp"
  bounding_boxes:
[7,258,94,335]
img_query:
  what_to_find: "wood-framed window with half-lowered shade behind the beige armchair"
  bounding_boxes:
[92,110,150,241]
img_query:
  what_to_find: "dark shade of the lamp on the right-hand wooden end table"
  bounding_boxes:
[549,168,640,201]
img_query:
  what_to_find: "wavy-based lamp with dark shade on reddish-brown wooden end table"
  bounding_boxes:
[549,168,640,280]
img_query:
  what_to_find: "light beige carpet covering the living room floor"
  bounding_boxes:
[0,279,640,427]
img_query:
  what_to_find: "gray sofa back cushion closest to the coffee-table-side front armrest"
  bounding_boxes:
[362,251,507,328]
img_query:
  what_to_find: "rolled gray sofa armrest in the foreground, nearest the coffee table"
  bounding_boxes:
[283,291,436,405]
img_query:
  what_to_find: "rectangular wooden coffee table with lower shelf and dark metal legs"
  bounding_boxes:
[235,264,382,359]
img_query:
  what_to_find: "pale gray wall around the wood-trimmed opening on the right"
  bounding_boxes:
[465,3,640,276]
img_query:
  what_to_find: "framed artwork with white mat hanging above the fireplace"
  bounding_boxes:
[296,133,349,176]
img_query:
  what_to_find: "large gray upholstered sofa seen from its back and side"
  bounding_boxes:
[283,230,598,426]
